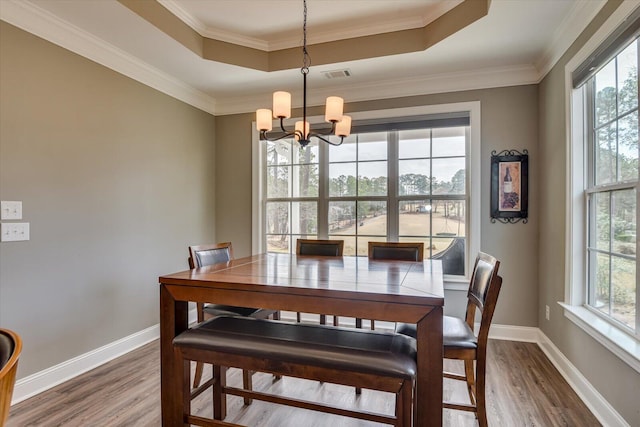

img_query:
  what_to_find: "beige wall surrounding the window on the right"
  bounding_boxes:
[538,1,640,426]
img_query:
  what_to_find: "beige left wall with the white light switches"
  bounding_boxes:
[0,22,215,378]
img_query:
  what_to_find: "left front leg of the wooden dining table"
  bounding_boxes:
[160,285,188,427]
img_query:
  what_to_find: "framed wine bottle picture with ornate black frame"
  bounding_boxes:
[491,150,529,224]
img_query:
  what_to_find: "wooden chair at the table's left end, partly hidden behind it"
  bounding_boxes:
[189,242,280,405]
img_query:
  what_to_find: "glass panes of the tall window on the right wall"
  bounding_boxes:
[583,39,640,335]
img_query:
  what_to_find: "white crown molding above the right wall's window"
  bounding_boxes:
[536,0,607,80]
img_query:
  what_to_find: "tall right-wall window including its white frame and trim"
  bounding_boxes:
[563,4,640,372]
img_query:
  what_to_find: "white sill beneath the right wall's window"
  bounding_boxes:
[558,302,640,372]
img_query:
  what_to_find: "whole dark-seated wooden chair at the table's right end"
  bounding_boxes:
[396,252,502,427]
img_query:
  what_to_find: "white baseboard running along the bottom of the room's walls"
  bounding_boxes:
[11,316,629,427]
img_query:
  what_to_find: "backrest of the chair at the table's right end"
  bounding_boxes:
[465,252,502,347]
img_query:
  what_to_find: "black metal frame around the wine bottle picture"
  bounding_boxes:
[491,149,529,224]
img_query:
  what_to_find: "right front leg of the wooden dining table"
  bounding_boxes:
[414,307,443,427]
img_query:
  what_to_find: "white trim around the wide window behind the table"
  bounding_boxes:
[251,101,482,291]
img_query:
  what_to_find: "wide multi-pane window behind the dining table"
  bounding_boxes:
[254,103,480,279]
